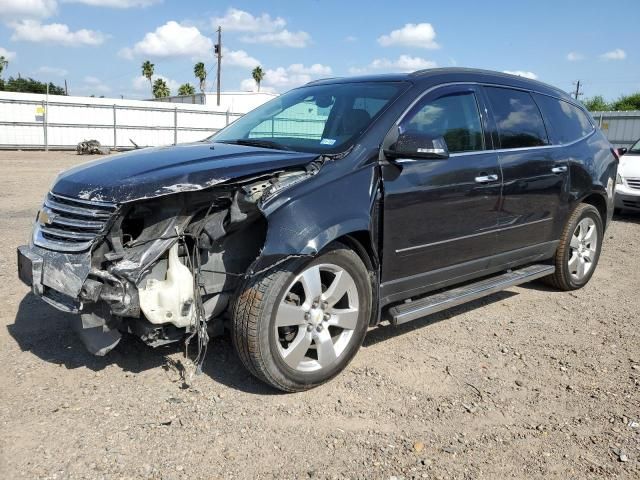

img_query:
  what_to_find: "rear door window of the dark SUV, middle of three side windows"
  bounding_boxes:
[485,87,549,148]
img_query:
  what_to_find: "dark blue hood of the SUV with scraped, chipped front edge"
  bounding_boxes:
[52,143,317,203]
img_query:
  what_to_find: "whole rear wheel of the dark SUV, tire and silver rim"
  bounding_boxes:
[544,203,604,291]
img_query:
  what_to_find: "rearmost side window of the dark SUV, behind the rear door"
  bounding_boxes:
[534,93,593,144]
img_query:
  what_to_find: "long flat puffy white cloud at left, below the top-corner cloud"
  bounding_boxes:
[11,20,107,47]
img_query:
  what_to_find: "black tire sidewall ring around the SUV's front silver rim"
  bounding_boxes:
[258,247,372,390]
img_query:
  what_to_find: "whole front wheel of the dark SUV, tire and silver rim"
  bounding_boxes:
[232,243,373,392]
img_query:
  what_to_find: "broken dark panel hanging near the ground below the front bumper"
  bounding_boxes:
[72,304,122,357]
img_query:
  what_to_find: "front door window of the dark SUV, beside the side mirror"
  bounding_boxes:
[402,91,484,153]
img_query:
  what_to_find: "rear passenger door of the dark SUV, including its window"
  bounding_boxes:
[484,86,568,253]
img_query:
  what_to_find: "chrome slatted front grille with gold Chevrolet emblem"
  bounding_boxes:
[33,192,116,252]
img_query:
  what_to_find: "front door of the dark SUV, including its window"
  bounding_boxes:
[381,85,502,303]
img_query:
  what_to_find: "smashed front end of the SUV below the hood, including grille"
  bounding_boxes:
[18,160,322,361]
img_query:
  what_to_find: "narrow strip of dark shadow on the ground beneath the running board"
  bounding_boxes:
[362,290,518,348]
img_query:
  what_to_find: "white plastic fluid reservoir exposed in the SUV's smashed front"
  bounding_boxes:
[138,243,195,327]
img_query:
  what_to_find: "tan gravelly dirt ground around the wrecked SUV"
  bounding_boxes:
[0,152,640,479]
